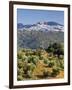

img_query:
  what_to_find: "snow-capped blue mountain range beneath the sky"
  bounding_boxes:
[17,21,64,32]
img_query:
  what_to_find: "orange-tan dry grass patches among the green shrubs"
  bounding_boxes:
[17,48,64,79]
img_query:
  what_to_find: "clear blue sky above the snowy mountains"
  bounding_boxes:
[17,9,64,25]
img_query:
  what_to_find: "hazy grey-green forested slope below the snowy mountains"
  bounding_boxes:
[17,30,64,49]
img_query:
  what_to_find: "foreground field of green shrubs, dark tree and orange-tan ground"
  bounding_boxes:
[17,43,64,81]
